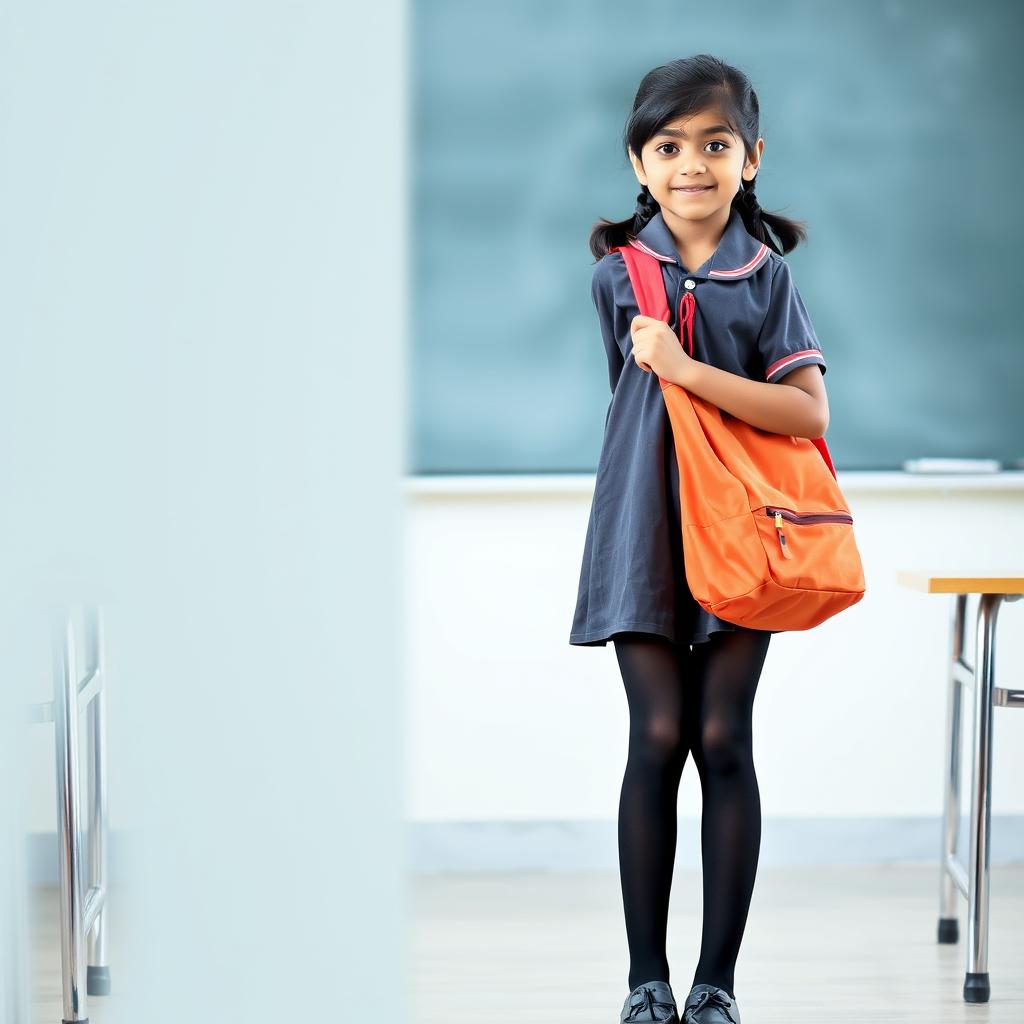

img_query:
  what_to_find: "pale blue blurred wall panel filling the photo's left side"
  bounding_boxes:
[8,0,412,1024]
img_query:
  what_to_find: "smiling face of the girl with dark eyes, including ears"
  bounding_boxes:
[630,111,764,222]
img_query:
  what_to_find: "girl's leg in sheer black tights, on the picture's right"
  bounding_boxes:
[690,629,771,995]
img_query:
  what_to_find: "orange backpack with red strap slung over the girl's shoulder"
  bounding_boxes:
[612,246,864,630]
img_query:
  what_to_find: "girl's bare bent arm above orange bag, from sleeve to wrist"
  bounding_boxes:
[670,359,828,438]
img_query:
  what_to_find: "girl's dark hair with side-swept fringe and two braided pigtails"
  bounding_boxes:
[590,53,807,260]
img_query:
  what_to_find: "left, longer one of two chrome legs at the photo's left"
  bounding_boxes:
[51,613,89,1024]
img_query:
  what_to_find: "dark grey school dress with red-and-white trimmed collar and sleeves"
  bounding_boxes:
[569,208,825,647]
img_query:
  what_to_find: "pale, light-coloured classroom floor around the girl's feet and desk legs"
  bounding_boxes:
[32,865,1024,1024]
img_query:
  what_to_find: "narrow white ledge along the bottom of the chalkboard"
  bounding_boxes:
[402,469,1024,498]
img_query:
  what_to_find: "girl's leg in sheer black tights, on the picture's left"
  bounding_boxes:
[613,633,690,990]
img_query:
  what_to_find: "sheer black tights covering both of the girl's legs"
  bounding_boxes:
[612,629,771,995]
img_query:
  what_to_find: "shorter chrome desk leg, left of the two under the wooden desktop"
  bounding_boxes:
[938,594,967,942]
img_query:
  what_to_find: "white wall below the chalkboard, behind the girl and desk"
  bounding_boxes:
[406,473,1024,823]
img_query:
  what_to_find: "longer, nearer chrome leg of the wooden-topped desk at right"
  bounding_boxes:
[964,594,1002,1002]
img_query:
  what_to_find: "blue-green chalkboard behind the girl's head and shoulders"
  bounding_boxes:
[409,0,1024,474]
